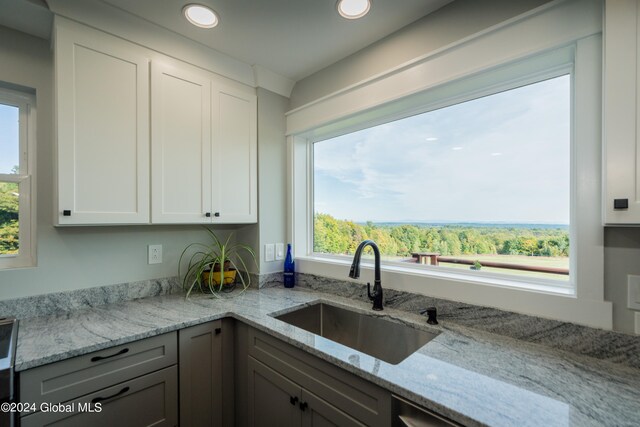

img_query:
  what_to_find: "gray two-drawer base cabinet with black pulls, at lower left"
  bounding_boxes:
[19,332,178,427]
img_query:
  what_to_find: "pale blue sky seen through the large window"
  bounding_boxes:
[314,76,571,224]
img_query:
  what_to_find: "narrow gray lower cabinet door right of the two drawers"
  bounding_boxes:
[178,319,233,427]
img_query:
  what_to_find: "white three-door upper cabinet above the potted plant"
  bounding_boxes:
[55,17,257,225]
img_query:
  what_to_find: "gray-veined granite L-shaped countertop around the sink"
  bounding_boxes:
[16,288,640,427]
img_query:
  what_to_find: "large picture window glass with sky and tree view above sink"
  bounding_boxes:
[313,74,572,282]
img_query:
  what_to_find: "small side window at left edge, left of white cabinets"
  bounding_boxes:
[0,88,35,268]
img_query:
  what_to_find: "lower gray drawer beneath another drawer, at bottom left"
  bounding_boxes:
[20,366,178,427]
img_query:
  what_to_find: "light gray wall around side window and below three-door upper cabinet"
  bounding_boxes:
[0,27,238,299]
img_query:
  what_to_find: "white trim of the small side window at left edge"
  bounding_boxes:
[0,88,36,270]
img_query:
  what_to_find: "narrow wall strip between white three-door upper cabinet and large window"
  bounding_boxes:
[238,88,289,274]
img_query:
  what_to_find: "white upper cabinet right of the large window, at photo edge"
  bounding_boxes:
[603,0,640,225]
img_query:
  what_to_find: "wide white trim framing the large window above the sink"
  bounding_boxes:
[287,1,613,329]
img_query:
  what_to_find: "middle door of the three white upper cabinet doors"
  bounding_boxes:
[151,62,212,223]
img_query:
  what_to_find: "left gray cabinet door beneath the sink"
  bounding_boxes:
[248,357,302,427]
